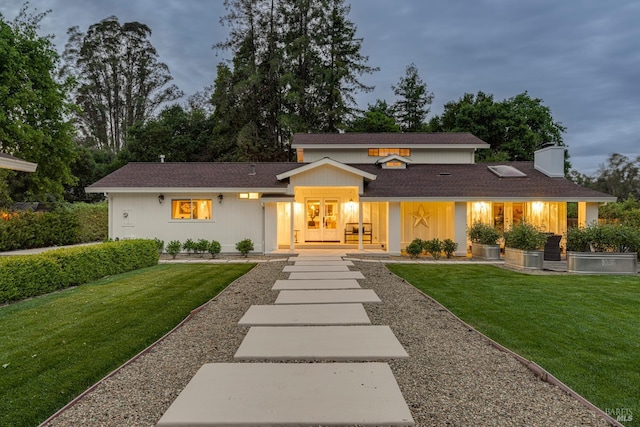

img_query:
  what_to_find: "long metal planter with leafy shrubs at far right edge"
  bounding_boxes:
[566,224,640,274]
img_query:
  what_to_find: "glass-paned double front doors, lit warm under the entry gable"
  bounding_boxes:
[304,198,340,242]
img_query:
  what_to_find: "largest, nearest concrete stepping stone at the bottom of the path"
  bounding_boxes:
[157,363,414,427]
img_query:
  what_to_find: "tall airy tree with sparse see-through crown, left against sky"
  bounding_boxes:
[63,16,182,152]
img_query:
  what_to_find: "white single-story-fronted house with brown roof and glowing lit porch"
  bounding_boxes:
[87,133,615,255]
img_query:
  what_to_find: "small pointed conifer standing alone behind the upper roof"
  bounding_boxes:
[391,64,433,132]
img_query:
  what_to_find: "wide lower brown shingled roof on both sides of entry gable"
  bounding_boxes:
[87,162,615,202]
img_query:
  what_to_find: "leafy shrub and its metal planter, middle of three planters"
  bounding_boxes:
[504,221,547,270]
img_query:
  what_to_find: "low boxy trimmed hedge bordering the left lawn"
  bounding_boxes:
[0,240,158,304]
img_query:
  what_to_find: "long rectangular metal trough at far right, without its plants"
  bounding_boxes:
[567,251,638,274]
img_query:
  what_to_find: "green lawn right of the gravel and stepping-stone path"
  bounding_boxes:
[388,264,640,425]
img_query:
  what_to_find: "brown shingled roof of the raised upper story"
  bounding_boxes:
[291,132,489,148]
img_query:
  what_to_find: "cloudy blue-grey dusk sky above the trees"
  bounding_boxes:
[0,0,640,175]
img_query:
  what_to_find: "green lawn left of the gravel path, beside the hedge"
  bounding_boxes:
[0,264,253,426]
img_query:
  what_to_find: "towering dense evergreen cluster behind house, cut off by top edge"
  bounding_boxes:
[212,0,376,160]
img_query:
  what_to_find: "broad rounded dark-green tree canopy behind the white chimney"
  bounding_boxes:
[429,91,570,166]
